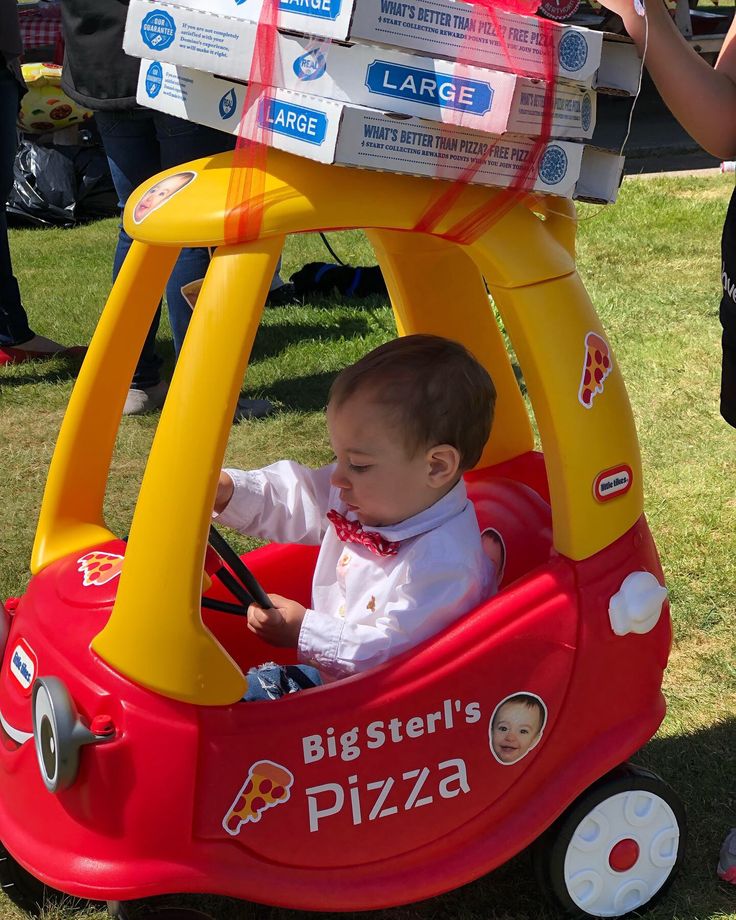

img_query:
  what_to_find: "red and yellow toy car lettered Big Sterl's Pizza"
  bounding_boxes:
[0,152,685,917]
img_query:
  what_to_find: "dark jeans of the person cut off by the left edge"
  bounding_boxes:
[0,68,33,345]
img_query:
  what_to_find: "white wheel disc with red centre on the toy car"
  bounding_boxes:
[563,789,680,917]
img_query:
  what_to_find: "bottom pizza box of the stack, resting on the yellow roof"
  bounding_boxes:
[138,60,623,203]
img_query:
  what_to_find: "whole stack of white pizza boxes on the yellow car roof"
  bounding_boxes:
[124,0,640,202]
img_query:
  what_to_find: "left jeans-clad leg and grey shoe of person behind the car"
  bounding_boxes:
[95,109,166,398]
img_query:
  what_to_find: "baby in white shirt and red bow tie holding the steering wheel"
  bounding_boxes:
[215,335,498,699]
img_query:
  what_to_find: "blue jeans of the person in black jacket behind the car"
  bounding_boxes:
[95,109,235,389]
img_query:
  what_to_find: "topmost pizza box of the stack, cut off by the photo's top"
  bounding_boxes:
[165,0,641,95]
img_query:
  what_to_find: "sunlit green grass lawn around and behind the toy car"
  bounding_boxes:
[0,177,736,920]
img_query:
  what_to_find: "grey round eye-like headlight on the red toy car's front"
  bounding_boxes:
[32,677,102,793]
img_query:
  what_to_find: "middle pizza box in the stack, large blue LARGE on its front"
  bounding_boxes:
[124,0,596,139]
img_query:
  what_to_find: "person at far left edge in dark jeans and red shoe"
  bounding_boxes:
[0,0,84,365]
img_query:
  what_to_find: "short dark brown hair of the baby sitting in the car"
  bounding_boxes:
[329,335,496,471]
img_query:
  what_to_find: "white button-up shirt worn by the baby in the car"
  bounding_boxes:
[217,460,498,680]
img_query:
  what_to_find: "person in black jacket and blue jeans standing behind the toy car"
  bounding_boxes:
[61,0,283,421]
